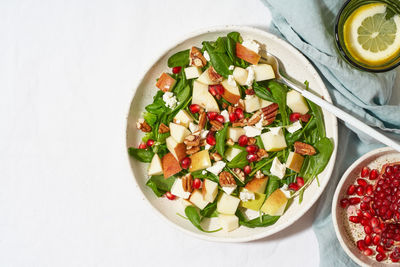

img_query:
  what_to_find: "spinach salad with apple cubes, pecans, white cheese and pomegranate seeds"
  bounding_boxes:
[128,32,334,232]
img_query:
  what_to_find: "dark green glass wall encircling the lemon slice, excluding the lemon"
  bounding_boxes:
[335,0,400,72]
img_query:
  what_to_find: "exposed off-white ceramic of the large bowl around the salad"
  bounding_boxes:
[126,26,338,242]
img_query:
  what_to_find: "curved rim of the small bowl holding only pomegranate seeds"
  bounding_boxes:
[331,147,395,266]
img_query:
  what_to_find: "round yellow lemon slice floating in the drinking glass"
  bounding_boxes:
[343,3,400,65]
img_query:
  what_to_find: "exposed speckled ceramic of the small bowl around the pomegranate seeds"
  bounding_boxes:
[332,147,400,266]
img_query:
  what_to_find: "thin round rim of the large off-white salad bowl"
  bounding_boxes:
[125,25,338,243]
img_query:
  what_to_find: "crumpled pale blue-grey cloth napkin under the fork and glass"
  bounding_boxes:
[262,0,400,266]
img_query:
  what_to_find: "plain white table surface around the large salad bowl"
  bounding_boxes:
[0,0,400,266]
